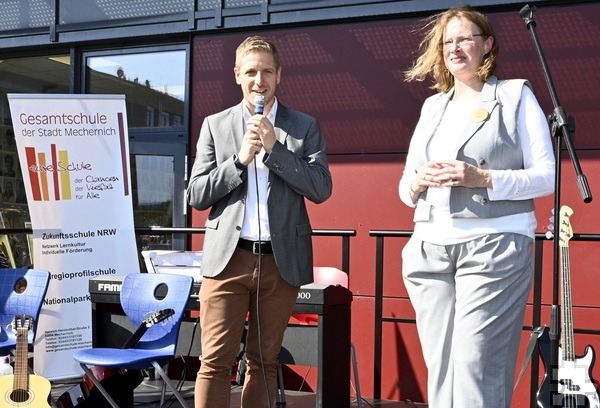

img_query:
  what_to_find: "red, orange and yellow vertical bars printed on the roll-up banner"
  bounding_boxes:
[25,144,72,201]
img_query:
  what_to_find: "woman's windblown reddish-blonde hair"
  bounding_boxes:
[405,5,499,92]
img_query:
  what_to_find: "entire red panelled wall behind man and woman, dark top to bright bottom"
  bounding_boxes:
[191,2,600,407]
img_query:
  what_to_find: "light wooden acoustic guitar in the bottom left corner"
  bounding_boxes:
[0,315,51,408]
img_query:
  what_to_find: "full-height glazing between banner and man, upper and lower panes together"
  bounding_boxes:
[84,47,187,250]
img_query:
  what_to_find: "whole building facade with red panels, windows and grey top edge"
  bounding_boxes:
[0,0,600,407]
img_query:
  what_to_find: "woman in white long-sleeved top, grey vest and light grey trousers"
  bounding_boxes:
[399,6,554,408]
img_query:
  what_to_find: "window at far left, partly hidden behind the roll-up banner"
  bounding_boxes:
[0,55,71,268]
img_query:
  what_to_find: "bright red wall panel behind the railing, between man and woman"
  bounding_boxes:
[309,155,412,295]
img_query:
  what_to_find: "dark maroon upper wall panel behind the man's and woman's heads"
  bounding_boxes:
[192,4,600,156]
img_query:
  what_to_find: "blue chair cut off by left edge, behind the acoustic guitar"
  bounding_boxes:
[0,269,50,355]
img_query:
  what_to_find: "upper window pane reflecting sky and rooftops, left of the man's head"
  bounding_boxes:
[86,50,186,128]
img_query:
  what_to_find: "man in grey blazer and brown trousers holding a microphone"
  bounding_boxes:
[187,37,332,408]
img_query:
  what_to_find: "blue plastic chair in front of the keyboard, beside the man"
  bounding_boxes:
[73,273,193,408]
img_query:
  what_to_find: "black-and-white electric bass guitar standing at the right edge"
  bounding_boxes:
[537,206,600,408]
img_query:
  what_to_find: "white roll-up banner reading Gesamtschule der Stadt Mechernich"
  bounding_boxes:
[8,94,139,379]
